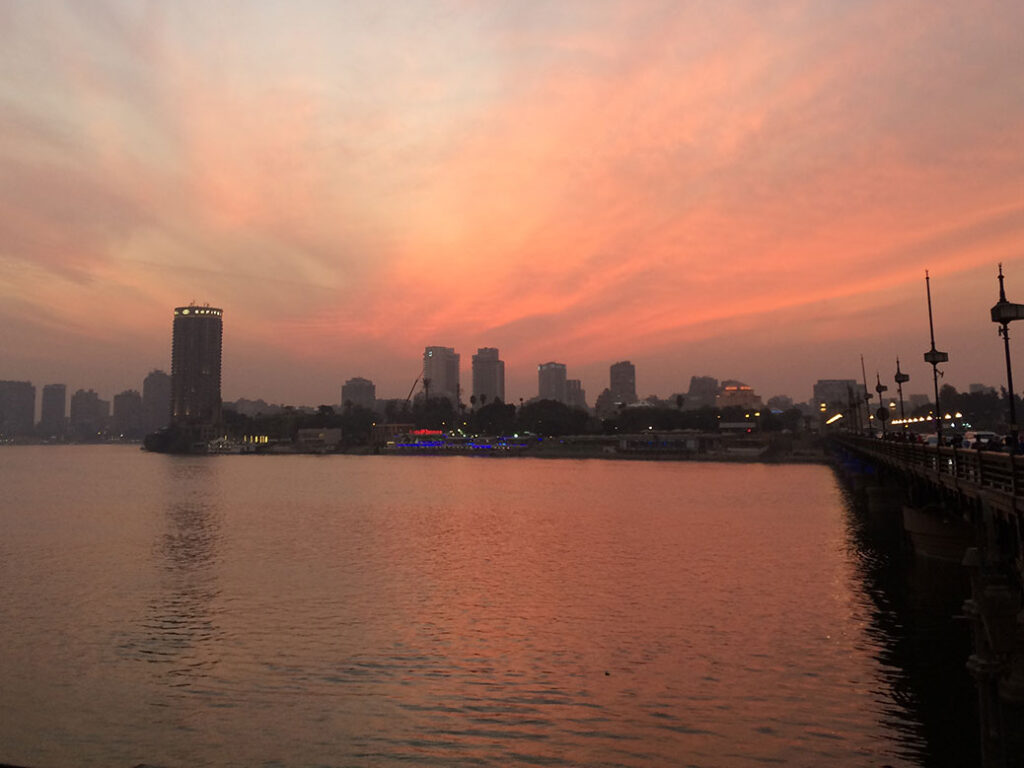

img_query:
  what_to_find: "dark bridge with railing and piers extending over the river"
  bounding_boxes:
[831,434,1024,768]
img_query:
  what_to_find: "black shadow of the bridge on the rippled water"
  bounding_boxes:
[845,490,981,768]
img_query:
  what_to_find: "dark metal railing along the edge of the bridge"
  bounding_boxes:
[839,435,1024,497]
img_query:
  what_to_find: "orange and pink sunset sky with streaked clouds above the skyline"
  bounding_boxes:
[0,0,1024,404]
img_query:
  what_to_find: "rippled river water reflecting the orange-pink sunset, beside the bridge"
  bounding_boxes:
[0,445,977,768]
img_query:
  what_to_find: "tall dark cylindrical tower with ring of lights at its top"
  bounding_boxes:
[171,304,223,426]
